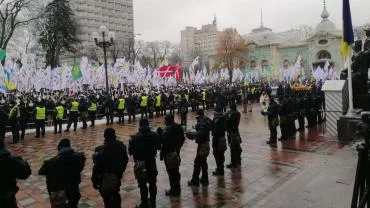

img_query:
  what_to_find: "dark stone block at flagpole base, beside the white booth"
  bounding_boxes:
[337,114,362,142]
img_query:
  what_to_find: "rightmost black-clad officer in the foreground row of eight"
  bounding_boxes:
[226,104,242,168]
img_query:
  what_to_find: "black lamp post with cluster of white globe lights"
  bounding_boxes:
[92,26,115,95]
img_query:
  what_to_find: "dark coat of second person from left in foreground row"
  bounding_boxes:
[39,148,86,192]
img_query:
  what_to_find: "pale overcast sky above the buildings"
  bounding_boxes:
[134,0,370,43]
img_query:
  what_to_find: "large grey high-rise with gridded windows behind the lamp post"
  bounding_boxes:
[70,0,134,52]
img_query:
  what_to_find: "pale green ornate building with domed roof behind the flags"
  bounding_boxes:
[244,4,343,74]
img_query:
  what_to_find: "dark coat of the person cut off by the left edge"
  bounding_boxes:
[0,150,31,197]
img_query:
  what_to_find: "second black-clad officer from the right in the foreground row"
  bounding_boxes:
[212,106,227,176]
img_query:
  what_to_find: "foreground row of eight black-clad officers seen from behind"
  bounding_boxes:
[0,104,242,208]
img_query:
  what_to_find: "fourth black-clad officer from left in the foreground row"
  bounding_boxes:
[129,119,161,208]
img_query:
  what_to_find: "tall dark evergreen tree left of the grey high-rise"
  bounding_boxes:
[39,0,79,68]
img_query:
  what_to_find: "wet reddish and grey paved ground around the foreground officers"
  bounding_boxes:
[2,105,357,208]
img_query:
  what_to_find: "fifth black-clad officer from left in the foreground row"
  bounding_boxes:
[158,114,185,196]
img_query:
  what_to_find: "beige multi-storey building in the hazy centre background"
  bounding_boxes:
[180,17,220,66]
